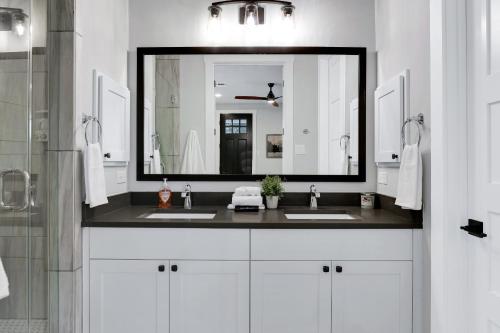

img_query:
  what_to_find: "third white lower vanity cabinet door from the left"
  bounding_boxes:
[251,261,331,333]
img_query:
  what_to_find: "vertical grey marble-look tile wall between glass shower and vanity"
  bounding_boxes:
[48,0,82,333]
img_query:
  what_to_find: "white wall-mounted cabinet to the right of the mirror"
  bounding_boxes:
[375,75,404,163]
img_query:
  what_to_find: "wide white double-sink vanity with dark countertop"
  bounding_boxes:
[83,197,422,333]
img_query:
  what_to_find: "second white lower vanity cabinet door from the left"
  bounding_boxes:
[170,261,250,333]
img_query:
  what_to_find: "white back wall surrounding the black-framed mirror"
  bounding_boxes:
[129,0,376,192]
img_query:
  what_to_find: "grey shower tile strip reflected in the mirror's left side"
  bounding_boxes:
[155,55,180,173]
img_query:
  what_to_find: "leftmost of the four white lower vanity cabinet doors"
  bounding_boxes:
[90,260,169,333]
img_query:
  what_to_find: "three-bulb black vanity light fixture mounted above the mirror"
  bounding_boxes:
[208,0,295,25]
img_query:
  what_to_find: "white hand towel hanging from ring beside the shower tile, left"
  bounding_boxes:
[83,143,108,208]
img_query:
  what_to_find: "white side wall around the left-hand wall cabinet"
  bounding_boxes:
[75,0,129,195]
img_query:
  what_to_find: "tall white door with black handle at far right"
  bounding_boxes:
[466,0,500,333]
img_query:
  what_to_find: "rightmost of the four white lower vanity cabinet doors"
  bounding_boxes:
[332,261,412,333]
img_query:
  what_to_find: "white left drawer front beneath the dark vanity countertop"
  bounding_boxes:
[89,228,250,260]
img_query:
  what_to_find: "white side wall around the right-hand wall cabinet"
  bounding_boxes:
[375,0,431,332]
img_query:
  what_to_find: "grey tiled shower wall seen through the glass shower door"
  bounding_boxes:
[0,49,48,320]
